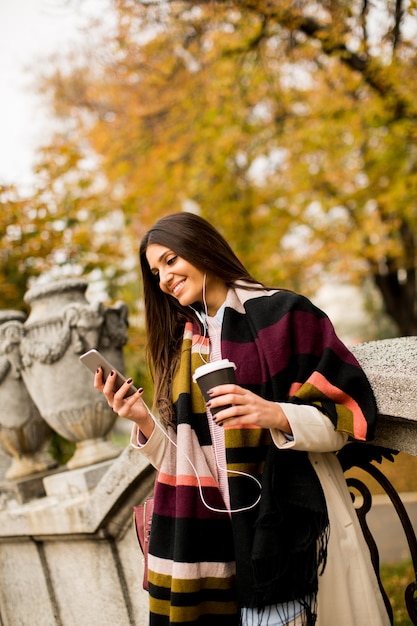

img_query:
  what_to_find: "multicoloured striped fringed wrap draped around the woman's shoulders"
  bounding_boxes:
[149,288,376,626]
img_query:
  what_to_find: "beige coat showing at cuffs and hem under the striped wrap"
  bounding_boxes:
[131,403,390,626]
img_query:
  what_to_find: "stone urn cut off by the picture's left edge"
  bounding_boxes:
[0,310,56,480]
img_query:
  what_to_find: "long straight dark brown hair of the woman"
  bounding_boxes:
[139,212,260,425]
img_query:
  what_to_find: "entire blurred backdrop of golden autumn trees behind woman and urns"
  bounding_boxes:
[0,0,417,374]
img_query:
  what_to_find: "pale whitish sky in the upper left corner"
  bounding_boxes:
[0,0,106,187]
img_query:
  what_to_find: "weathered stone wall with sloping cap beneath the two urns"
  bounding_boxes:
[0,448,154,626]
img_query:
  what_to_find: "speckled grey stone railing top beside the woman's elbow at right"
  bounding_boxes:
[350,337,417,422]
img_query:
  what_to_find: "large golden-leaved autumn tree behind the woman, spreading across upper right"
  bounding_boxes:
[25,0,417,335]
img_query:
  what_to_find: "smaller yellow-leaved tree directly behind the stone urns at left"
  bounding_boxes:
[0,139,131,310]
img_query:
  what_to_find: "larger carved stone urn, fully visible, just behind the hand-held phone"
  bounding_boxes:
[20,279,127,469]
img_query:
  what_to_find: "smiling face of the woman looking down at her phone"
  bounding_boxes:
[146,243,227,315]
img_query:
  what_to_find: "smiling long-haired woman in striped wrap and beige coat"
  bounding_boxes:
[95,213,389,626]
